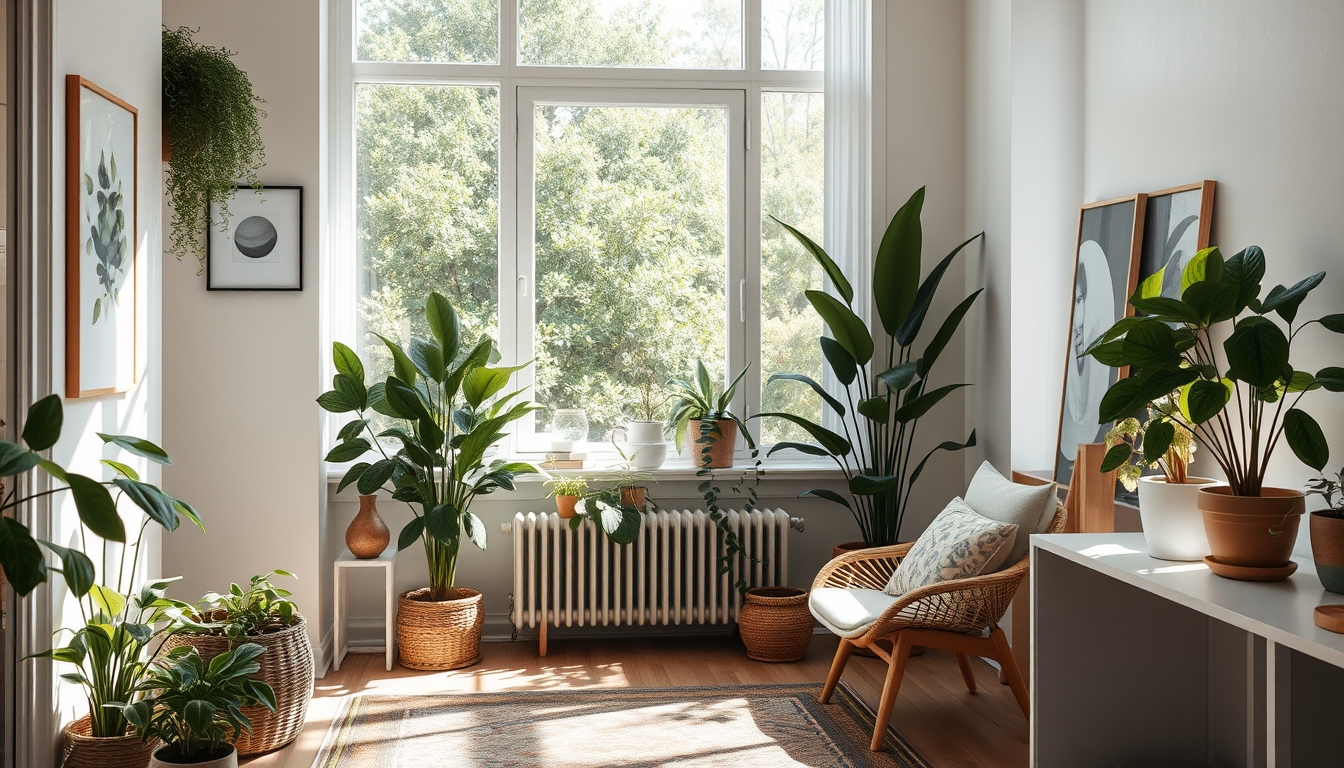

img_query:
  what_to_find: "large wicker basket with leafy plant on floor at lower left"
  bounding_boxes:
[164,570,313,756]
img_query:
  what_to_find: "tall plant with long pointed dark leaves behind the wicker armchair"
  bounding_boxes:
[753,187,984,546]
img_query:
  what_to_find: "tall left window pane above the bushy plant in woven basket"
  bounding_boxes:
[355,85,499,381]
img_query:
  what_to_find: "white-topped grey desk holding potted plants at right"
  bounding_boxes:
[1031,534,1344,768]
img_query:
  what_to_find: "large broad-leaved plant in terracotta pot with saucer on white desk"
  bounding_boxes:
[1083,246,1344,581]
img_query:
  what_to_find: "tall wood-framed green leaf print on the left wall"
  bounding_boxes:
[66,75,140,398]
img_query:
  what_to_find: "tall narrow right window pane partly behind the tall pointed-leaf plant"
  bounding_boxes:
[761,93,824,443]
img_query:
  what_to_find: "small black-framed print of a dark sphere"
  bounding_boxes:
[206,186,304,291]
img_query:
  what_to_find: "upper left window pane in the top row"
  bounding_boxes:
[355,0,500,63]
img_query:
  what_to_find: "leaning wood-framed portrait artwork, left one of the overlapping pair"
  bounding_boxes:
[1054,194,1148,486]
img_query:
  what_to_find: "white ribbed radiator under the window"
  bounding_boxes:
[509,510,802,656]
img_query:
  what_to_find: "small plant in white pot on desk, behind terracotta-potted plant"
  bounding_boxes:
[1101,406,1218,561]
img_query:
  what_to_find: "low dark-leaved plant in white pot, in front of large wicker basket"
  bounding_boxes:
[116,643,276,768]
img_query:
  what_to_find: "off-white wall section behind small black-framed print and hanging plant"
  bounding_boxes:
[163,0,327,656]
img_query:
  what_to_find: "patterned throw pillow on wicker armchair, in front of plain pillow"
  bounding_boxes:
[886,496,1017,597]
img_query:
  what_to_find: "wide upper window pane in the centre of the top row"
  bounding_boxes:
[519,0,742,69]
